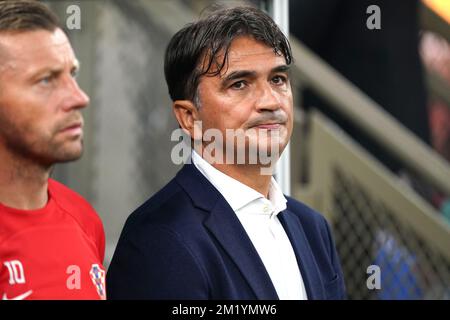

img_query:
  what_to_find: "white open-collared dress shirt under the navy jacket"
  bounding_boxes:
[192,151,307,300]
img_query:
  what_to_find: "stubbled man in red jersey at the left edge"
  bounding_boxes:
[0,0,106,300]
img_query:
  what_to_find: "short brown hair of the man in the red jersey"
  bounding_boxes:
[0,0,59,33]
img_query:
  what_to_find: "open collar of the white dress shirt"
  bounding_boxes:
[192,151,287,215]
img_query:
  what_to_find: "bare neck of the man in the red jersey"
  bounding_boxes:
[0,150,51,210]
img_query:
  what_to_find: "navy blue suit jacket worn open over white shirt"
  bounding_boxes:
[106,164,345,299]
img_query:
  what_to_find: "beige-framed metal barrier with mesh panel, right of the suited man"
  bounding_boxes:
[292,112,450,299]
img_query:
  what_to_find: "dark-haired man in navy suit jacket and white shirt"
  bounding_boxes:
[107,7,345,300]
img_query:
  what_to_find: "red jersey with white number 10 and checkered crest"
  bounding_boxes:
[0,179,106,300]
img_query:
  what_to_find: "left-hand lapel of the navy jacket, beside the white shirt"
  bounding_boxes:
[177,165,278,300]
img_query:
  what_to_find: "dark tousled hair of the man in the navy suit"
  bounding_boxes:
[164,7,292,101]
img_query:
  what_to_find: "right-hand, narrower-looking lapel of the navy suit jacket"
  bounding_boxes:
[278,210,325,299]
